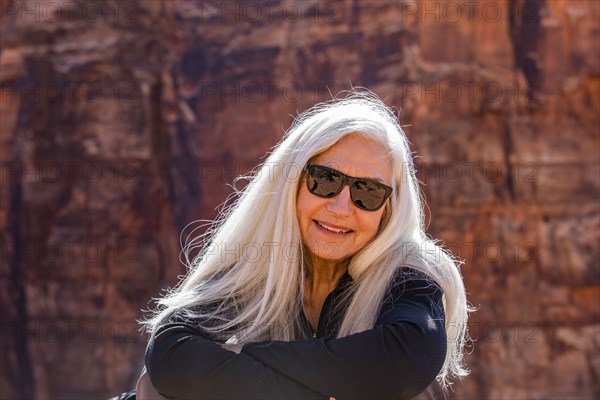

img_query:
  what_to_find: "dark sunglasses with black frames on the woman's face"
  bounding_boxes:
[304,164,392,211]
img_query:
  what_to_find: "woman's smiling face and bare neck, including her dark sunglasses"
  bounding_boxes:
[296,138,392,332]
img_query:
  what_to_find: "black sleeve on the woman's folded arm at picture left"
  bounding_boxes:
[146,323,327,399]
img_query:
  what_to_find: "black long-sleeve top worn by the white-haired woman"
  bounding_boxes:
[146,270,446,400]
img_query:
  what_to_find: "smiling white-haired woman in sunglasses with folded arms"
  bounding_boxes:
[141,92,469,400]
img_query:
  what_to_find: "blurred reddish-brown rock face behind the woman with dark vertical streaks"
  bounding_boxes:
[0,0,600,399]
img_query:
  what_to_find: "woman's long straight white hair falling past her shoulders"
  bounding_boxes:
[143,91,470,387]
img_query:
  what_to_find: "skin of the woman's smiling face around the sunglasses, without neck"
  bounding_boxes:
[297,135,392,265]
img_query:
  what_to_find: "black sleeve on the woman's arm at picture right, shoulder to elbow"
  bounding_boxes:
[242,279,446,400]
